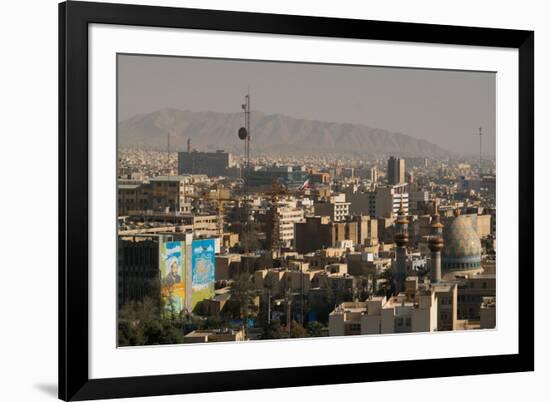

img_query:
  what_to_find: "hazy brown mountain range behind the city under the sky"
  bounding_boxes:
[118,109,450,157]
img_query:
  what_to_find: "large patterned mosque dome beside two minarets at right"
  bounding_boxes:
[441,215,481,271]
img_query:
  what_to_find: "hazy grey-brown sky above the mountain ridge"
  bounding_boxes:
[118,51,496,155]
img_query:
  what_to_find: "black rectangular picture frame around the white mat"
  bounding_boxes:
[59,1,534,400]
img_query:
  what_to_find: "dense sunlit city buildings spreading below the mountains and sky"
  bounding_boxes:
[118,96,496,346]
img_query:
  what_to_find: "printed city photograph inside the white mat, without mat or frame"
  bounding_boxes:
[116,54,497,347]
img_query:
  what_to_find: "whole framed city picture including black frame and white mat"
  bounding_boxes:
[59,1,534,400]
